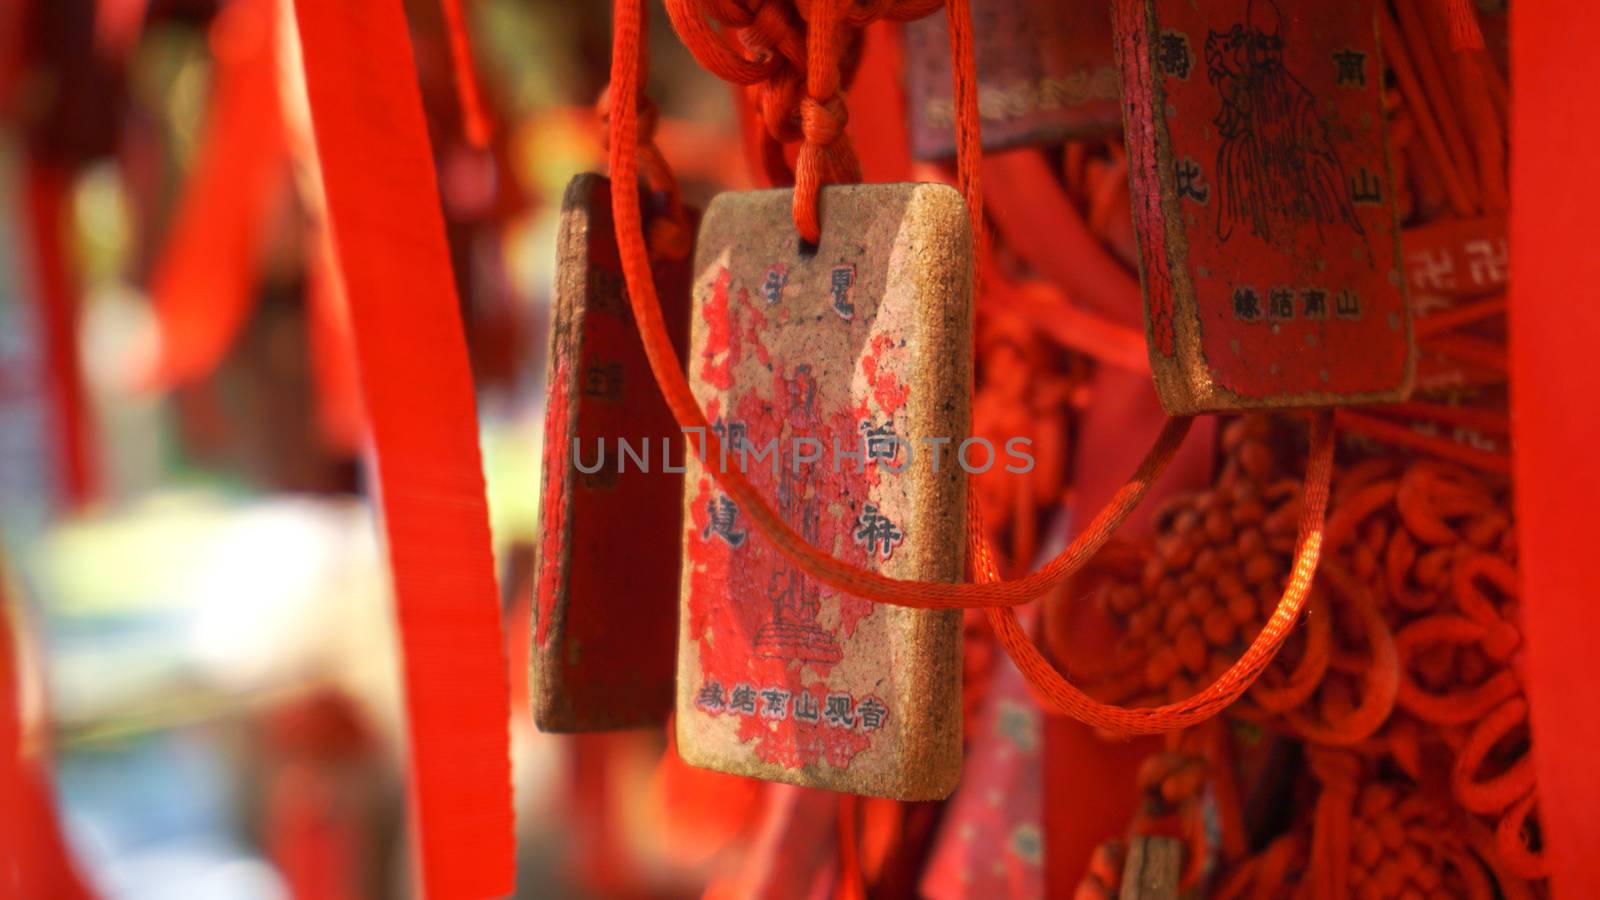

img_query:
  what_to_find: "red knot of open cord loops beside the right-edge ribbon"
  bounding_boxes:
[1305,460,1544,881]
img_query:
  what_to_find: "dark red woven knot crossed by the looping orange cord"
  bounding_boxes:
[1081,416,1398,745]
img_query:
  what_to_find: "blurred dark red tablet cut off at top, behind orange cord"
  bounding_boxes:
[904,0,1122,159]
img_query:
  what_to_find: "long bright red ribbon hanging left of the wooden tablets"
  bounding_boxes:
[294,0,514,898]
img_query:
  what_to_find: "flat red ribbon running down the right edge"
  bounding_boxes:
[1509,0,1600,897]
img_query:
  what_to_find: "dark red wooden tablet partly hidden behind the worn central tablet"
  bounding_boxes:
[533,175,690,732]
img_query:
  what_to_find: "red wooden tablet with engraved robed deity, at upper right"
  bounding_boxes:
[1117,0,1413,415]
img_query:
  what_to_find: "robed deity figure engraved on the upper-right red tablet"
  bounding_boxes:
[1205,0,1363,250]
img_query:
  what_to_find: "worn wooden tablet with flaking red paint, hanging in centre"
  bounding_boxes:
[677,184,966,799]
